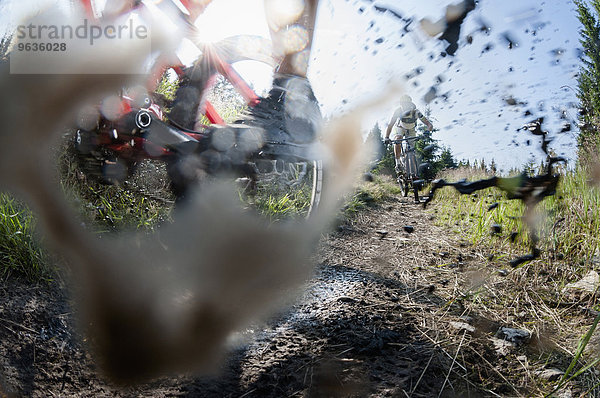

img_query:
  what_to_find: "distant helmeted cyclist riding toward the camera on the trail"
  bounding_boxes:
[385,95,433,175]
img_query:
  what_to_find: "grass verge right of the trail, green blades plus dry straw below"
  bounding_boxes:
[430,165,600,396]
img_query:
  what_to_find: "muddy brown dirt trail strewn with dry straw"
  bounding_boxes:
[0,198,552,397]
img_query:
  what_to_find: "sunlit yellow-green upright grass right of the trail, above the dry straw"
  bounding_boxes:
[432,166,600,262]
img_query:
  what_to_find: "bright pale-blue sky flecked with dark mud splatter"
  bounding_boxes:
[0,0,580,169]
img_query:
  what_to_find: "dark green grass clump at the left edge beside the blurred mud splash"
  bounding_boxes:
[0,193,51,281]
